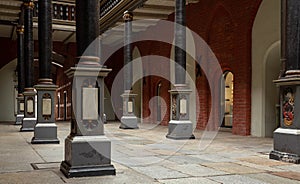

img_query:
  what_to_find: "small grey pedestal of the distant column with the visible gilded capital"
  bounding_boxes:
[120,90,139,129]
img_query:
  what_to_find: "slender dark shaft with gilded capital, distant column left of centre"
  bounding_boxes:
[123,11,133,90]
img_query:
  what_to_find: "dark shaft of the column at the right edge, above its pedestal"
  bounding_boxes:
[282,0,300,70]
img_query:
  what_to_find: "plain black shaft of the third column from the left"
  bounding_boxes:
[38,0,52,79]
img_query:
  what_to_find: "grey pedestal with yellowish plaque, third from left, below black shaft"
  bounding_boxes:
[31,79,59,144]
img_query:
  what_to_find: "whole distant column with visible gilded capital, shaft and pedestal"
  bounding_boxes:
[120,11,138,129]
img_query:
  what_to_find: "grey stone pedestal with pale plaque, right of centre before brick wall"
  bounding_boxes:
[167,84,195,139]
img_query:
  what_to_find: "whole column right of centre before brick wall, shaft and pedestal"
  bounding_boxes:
[167,0,195,139]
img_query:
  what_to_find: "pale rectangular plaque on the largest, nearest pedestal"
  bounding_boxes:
[82,88,98,120]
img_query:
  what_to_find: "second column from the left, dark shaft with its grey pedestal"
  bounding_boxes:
[20,0,36,131]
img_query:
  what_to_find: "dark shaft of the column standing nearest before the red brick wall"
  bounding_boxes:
[175,0,186,84]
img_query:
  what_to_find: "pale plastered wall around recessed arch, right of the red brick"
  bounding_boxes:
[251,0,281,137]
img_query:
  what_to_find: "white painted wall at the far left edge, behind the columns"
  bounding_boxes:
[0,60,17,121]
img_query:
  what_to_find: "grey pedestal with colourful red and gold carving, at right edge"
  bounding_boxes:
[270,76,300,164]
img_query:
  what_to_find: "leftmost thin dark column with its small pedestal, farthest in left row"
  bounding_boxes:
[15,10,25,125]
